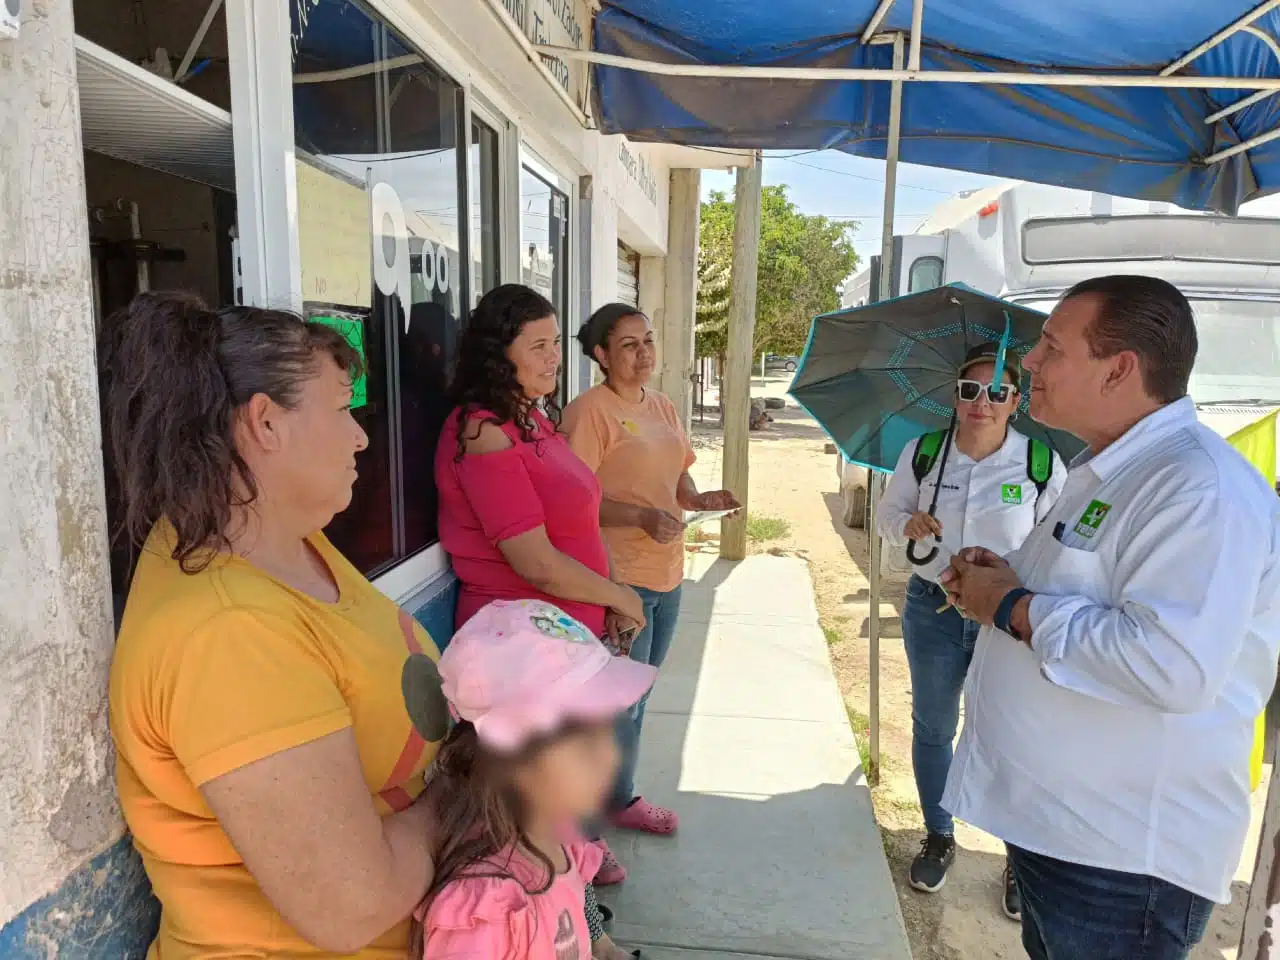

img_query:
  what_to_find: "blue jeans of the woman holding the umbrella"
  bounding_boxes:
[902,576,978,836]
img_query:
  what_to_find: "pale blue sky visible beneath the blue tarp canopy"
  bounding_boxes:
[703,150,998,262]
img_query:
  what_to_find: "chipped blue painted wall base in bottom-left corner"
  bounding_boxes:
[0,836,160,960]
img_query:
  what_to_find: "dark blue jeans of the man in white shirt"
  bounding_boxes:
[1009,846,1213,960]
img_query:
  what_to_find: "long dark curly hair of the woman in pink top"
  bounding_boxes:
[449,283,561,461]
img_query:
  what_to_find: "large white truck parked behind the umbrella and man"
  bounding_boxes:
[838,183,1280,526]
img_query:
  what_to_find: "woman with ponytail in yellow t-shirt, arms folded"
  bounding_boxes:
[104,294,448,960]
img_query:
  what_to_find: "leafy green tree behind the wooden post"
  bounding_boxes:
[696,184,858,356]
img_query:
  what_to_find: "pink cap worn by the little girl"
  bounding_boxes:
[439,600,658,753]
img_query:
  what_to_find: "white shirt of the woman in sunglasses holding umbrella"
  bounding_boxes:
[876,430,1066,581]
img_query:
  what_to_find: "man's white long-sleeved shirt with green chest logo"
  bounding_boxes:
[942,399,1280,904]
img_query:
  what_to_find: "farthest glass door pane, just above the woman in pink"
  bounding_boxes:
[520,166,573,403]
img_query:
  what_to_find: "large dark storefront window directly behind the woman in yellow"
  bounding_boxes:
[292,0,470,573]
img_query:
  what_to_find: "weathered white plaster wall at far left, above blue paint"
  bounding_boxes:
[0,0,120,927]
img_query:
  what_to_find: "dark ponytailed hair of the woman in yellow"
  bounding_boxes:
[100,293,362,573]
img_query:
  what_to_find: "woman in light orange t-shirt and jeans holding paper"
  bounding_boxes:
[564,303,739,849]
